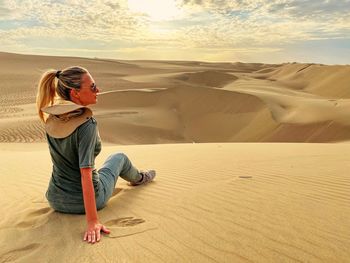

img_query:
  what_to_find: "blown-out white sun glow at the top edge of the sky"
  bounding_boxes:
[128,0,181,21]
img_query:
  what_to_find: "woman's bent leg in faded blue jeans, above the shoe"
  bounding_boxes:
[98,153,142,207]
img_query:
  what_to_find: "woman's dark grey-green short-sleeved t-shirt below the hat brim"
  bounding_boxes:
[46,117,101,205]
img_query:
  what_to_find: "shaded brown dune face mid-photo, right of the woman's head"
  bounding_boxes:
[95,87,264,143]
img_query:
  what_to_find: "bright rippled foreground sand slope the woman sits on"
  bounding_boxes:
[0,143,350,262]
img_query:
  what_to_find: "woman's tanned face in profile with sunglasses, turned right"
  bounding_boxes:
[71,73,100,106]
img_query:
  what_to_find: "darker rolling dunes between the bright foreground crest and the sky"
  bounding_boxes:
[0,53,350,144]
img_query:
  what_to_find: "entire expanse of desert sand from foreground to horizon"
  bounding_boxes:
[0,53,350,262]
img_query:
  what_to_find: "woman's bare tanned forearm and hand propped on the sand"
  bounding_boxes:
[80,168,110,243]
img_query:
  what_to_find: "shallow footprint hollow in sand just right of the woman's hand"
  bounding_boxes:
[104,216,158,238]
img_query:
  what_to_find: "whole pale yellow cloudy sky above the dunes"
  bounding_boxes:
[0,0,350,64]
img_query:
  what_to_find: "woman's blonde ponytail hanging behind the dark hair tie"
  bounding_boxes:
[36,70,57,122]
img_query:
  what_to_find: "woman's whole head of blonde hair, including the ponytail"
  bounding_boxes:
[36,66,88,122]
